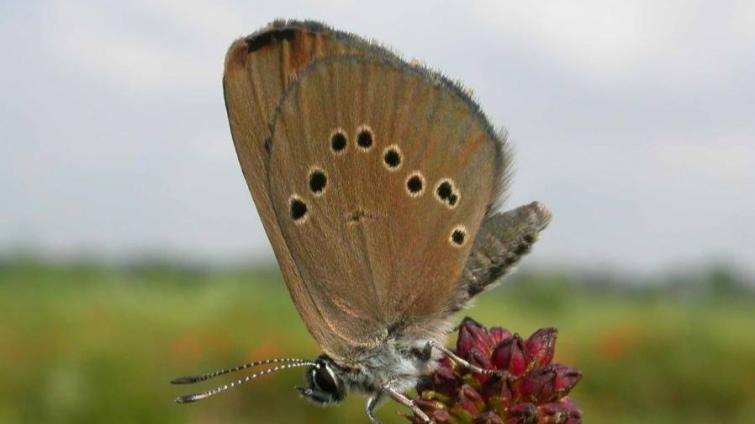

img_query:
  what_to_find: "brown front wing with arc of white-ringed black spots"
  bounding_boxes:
[269,56,505,357]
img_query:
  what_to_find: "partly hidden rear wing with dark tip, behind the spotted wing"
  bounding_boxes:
[223,21,402,352]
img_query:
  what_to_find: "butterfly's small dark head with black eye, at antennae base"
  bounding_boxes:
[297,355,346,405]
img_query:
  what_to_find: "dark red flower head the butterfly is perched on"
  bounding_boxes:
[414,318,582,424]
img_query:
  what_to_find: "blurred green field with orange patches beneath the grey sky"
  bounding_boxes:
[0,261,755,423]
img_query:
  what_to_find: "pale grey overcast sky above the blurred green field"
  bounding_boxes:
[0,0,755,272]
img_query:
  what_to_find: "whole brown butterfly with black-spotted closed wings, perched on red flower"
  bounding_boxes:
[173,20,551,422]
